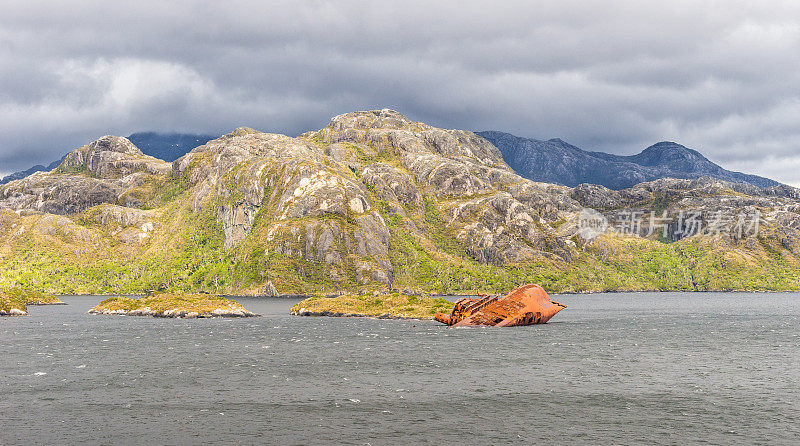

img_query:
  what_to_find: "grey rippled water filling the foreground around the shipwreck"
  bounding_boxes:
[0,293,800,445]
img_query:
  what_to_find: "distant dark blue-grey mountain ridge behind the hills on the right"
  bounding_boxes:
[478,131,780,190]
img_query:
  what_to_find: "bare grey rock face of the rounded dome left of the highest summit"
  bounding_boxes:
[173,123,393,284]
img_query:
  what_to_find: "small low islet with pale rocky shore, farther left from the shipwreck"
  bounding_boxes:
[89,293,258,319]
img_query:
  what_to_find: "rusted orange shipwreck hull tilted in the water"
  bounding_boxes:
[434,284,567,327]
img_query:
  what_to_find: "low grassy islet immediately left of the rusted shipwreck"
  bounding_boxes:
[290,293,453,319]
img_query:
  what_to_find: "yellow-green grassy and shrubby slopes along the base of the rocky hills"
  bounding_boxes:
[0,143,800,294]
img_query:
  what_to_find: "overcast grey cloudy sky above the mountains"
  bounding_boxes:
[0,0,800,185]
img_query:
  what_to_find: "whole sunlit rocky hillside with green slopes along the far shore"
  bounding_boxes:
[0,110,800,293]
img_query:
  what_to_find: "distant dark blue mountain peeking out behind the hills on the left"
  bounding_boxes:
[0,132,216,184]
